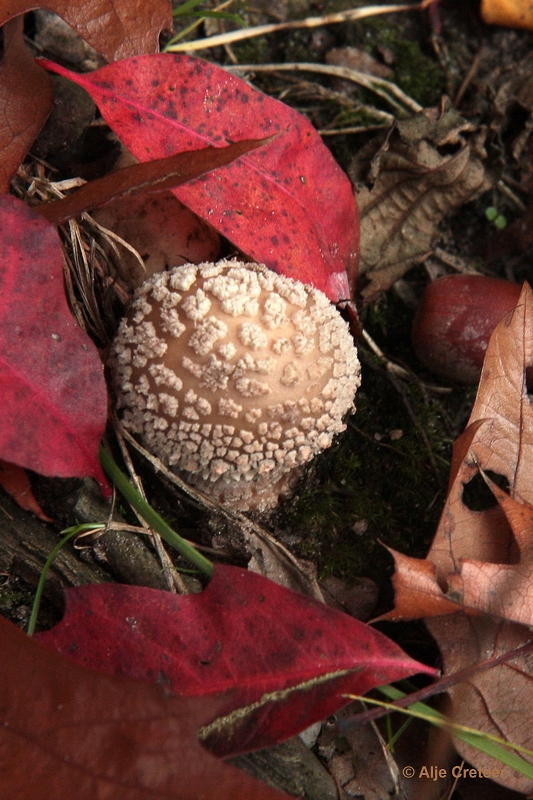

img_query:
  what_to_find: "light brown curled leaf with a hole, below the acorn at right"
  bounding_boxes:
[386,284,533,625]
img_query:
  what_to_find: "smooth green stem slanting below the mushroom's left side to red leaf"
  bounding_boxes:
[100,446,214,578]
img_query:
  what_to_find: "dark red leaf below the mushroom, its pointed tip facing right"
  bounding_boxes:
[40,566,435,756]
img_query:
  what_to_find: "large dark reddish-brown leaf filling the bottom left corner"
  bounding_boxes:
[0,617,289,800]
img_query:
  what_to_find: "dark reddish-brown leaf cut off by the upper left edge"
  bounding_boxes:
[0,17,54,193]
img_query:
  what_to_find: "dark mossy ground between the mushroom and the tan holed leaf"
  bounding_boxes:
[280,295,473,585]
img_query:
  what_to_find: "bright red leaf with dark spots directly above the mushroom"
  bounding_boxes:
[41,54,359,301]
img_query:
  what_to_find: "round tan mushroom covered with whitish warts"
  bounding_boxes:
[111,260,360,510]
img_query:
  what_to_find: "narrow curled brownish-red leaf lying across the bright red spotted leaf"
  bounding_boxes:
[39,140,263,225]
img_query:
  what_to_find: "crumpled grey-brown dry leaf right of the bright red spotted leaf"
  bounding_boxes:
[349,102,491,301]
